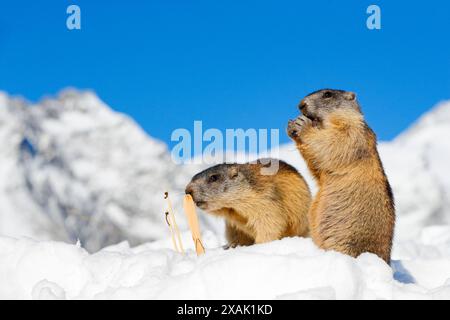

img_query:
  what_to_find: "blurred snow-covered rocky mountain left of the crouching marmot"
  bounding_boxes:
[0,90,188,250]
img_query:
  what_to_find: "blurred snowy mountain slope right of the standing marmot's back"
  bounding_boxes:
[380,101,450,237]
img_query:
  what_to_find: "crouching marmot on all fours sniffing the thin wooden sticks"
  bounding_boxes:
[186,159,311,247]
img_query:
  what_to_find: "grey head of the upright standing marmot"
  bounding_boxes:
[299,89,361,121]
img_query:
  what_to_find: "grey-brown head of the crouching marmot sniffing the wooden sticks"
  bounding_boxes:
[186,164,252,211]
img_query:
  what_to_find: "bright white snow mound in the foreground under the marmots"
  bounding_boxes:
[0,227,450,299]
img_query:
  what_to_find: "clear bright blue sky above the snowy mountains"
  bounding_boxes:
[0,0,450,150]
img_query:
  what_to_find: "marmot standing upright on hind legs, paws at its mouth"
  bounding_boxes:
[288,89,395,263]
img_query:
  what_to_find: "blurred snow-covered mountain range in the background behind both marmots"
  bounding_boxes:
[0,90,450,251]
